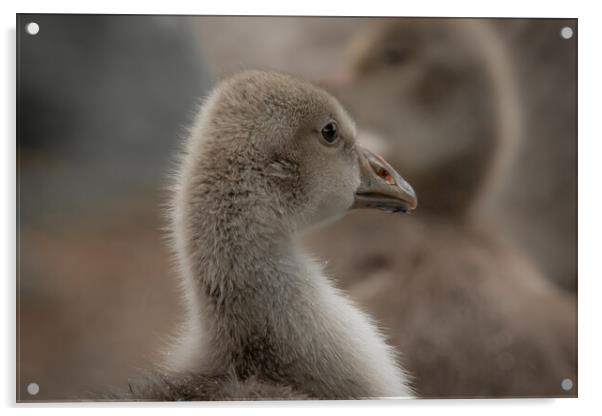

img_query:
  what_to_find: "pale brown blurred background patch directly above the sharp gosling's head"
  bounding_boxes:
[194,16,365,81]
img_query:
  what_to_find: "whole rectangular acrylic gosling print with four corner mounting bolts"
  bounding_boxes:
[17,14,578,402]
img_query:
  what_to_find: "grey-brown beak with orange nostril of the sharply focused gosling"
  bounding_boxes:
[351,147,418,213]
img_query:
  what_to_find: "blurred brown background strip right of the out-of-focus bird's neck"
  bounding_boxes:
[496,19,579,291]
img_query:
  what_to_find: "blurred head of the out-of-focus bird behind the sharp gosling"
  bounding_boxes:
[334,18,508,215]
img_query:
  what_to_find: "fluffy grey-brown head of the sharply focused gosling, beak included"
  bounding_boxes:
[181,71,417,236]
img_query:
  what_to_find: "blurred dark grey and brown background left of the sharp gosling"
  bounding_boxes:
[16,15,207,401]
